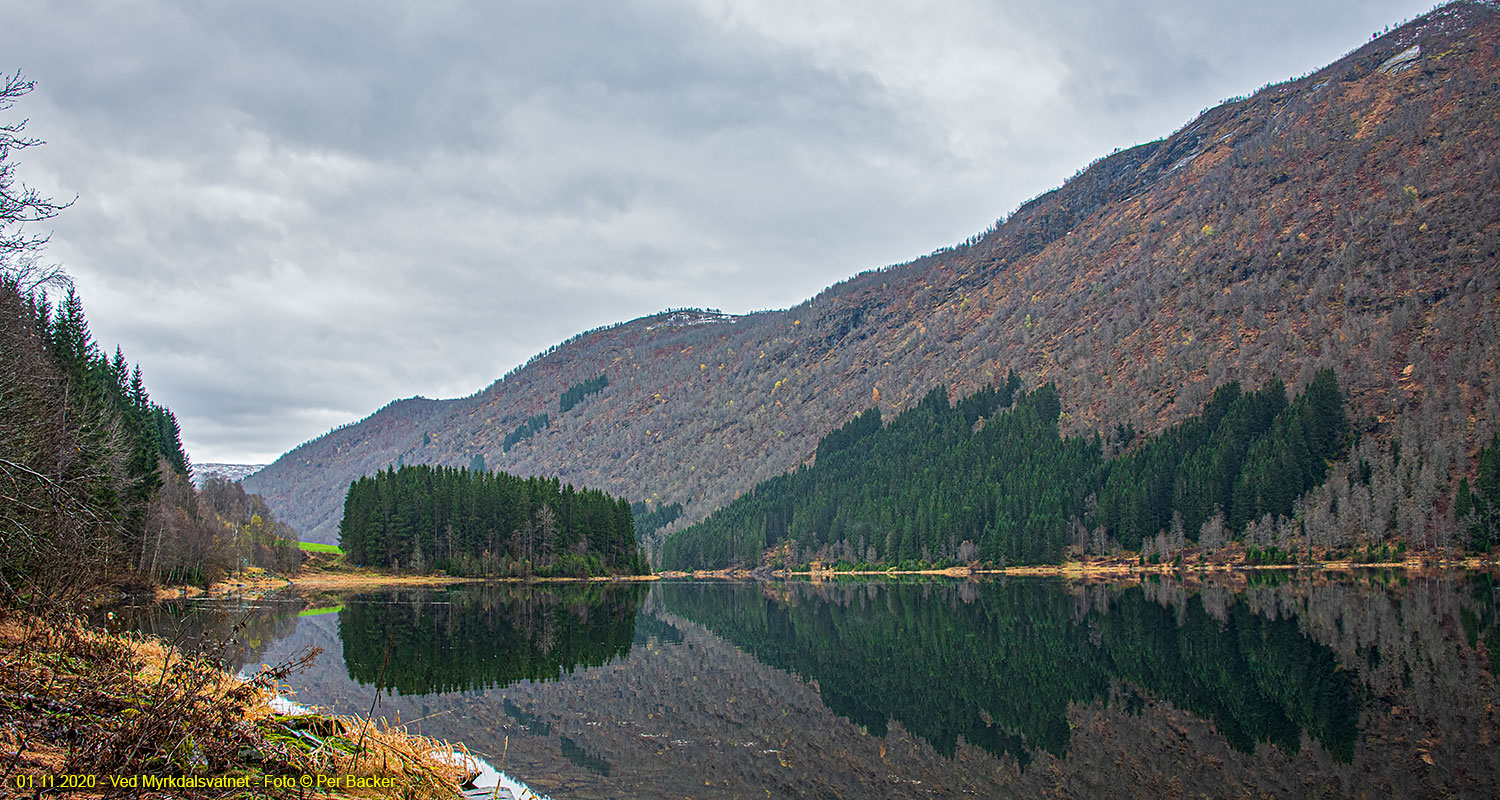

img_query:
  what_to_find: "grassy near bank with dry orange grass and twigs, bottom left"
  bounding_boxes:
[0,611,467,798]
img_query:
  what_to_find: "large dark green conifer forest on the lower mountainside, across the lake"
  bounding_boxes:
[662,371,1349,569]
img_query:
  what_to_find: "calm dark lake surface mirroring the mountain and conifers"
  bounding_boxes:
[120,572,1500,800]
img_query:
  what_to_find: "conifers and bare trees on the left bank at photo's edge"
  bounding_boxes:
[0,263,302,591]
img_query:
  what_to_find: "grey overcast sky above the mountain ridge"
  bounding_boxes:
[0,0,1431,462]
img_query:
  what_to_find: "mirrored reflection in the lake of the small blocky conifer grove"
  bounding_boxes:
[339,584,647,695]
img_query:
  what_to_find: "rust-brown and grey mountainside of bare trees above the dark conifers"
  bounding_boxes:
[245,3,1500,540]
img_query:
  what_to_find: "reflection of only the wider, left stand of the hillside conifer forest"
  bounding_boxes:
[662,581,1109,762]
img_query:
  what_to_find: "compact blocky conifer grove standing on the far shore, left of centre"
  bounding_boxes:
[339,465,650,576]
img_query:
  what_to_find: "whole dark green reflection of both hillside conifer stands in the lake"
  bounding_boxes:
[662,581,1358,764]
